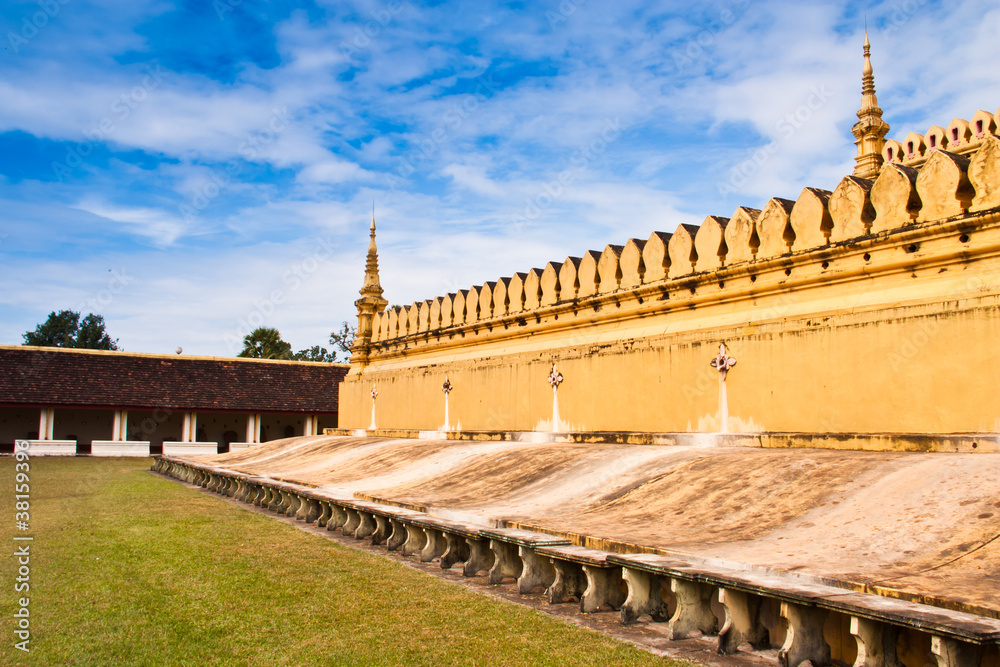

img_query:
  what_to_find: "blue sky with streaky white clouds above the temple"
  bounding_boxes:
[0,0,1000,356]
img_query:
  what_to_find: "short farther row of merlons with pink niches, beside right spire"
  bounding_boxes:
[882,109,1000,168]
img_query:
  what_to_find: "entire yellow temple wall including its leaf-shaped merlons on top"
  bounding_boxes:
[340,135,1000,451]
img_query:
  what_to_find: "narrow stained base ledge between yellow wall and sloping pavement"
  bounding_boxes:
[323,428,1000,454]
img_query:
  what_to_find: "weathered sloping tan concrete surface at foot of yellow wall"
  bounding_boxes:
[190,436,1000,618]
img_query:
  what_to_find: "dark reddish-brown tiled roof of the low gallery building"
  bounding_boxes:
[0,345,348,414]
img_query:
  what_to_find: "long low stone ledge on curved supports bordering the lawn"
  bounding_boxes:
[152,456,1000,667]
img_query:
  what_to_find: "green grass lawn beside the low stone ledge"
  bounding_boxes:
[0,457,680,666]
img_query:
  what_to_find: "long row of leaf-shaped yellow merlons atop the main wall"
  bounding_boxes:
[364,129,1000,355]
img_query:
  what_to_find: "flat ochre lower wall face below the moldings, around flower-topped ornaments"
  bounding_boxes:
[341,297,1000,433]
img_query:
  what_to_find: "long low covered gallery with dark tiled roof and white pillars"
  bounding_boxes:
[0,346,348,456]
